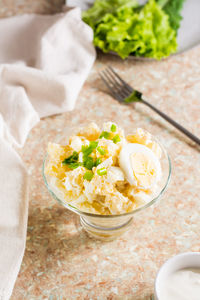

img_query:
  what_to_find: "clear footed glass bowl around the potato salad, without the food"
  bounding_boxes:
[42,130,171,241]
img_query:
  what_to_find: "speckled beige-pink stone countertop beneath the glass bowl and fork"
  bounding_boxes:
[0,0,200,300]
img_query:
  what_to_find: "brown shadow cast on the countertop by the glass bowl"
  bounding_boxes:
[24,204,104,269]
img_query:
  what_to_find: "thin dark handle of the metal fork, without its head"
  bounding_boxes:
[141,99,200,145]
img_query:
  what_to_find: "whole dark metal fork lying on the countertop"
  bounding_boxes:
[99,66,200,145]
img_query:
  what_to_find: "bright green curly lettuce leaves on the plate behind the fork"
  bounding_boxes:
[83,0,177,59]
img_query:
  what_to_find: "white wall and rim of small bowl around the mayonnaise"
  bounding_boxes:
[154,252,200,300]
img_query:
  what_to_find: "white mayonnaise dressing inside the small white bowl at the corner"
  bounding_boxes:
[159,268,200,300]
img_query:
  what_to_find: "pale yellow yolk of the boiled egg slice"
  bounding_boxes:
[130,152,156,187]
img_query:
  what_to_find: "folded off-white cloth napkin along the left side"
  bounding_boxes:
[0,8,95,300]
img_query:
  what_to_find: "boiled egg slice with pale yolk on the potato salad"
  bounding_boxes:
[119,143,161,189]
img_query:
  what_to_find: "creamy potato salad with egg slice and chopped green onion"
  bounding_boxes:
[45,122,162,215]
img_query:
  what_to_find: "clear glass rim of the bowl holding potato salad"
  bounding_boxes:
[42,137,172,219]
